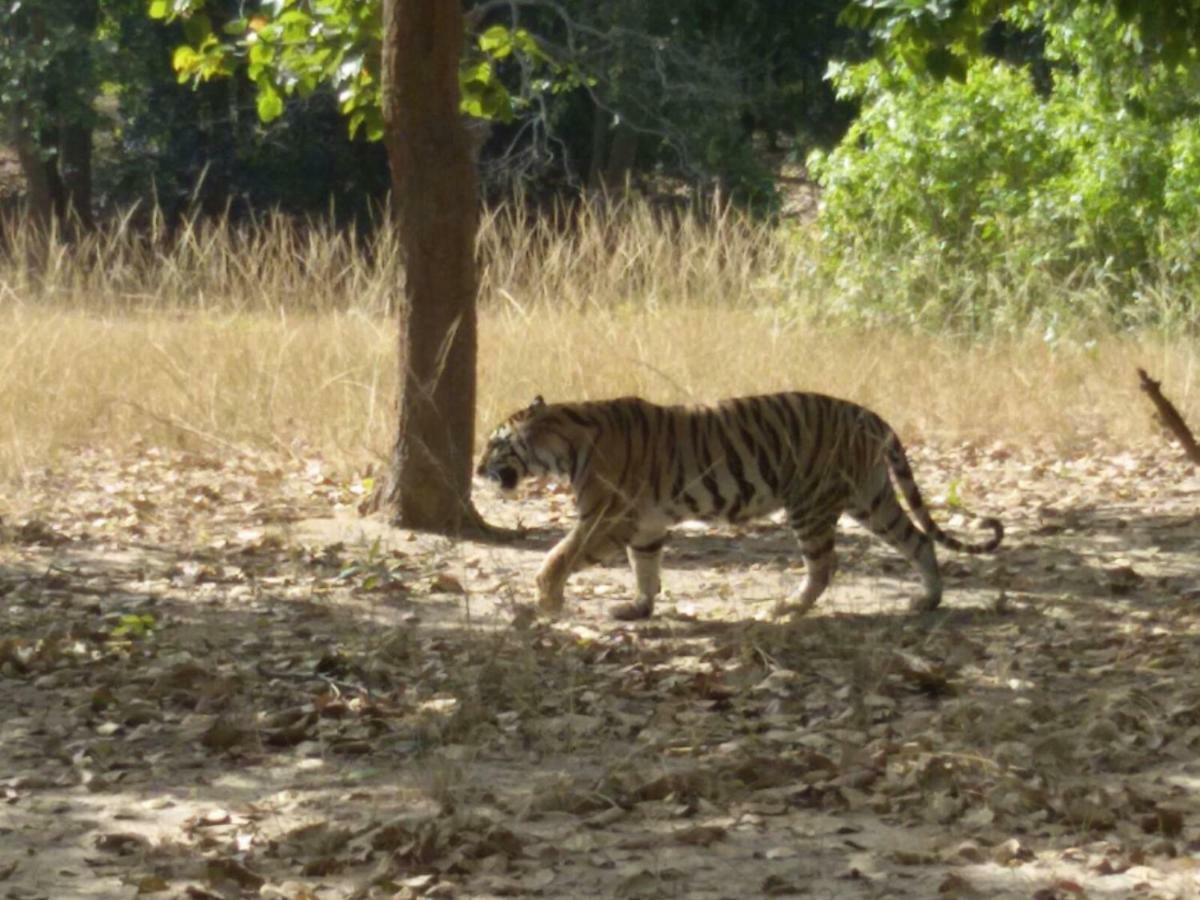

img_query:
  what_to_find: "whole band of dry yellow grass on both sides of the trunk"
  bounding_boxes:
[0,203,1200,487]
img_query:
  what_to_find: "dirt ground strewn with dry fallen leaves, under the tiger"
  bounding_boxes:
[0,446,1200,899]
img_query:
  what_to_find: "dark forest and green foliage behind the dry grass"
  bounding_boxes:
[11,0,1200,331]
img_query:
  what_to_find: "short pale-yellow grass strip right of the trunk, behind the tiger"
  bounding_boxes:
[480,307,1200,449]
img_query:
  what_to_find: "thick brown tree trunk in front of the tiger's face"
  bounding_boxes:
[376,0,480,534]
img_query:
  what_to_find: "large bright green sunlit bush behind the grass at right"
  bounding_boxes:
[810,2,1200,323]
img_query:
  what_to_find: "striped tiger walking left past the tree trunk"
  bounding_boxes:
[476,392,1004,619]
